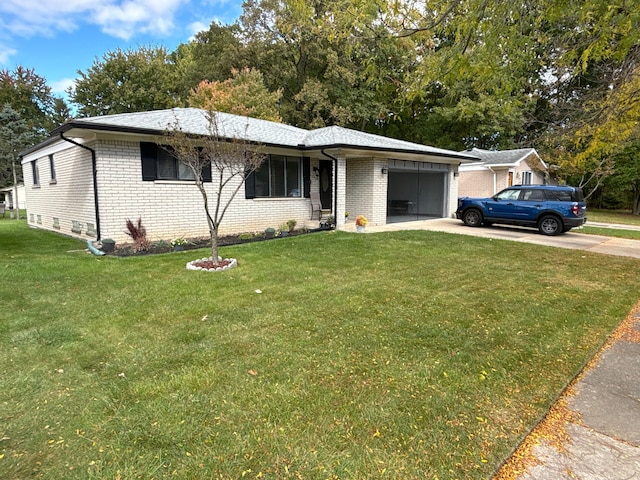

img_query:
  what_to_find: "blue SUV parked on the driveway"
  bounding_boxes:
[456,185,587,235]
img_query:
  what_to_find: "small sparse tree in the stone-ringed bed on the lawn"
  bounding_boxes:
[165,111,265,265]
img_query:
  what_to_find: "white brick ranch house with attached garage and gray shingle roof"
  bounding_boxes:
[21,108,477,242]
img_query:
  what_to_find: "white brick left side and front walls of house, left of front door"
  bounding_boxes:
[23,140,318,242]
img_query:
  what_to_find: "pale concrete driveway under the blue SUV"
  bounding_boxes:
[344,218,640,258]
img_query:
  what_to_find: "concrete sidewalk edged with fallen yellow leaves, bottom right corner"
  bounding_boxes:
[504,313,640,480]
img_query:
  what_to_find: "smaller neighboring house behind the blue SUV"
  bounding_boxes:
[458,148,549,197]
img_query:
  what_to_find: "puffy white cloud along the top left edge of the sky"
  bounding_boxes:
[0,0,189,39]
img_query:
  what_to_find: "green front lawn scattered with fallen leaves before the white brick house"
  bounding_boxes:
[0,222,640,479]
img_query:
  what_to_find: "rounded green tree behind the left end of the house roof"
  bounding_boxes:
[69,46,184,116]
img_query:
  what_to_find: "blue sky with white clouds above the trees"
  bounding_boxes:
[0,0,242,96]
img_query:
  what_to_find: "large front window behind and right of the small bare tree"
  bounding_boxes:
[255,155,302,197]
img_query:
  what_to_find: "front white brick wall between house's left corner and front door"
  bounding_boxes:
[97,140,317,241]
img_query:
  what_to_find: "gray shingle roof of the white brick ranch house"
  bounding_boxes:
[52,108,477,161]
